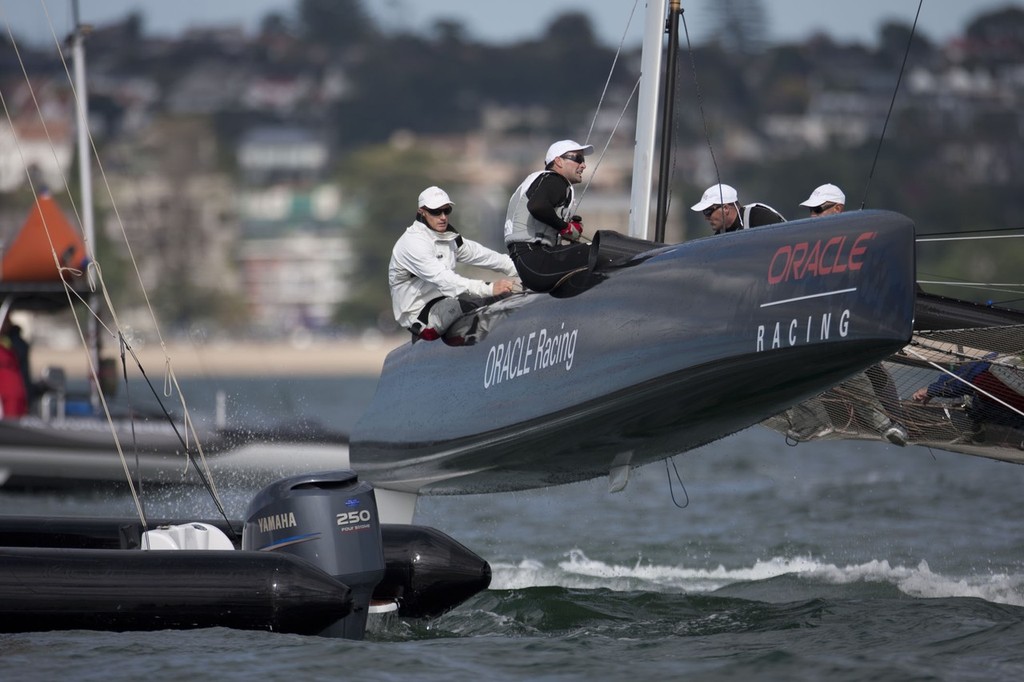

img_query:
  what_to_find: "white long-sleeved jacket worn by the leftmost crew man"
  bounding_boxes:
[387,221,516,329]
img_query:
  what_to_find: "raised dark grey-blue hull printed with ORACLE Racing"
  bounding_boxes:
[350,211,914,494]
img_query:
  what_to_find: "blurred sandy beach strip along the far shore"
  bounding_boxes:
[31,335,409,379]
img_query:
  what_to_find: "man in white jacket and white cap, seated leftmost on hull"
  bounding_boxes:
[387,187,517,341]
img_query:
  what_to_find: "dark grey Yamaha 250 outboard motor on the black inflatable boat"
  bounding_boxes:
[242,470,384,639]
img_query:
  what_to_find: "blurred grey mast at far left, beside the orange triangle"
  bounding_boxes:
[72,0,99,408]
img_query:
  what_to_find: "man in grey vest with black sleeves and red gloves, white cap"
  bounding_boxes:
[505,139,594,292]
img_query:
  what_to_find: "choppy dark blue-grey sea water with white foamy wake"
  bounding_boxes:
[0,380,1024,680]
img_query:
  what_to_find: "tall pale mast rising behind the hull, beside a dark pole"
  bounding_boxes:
[630,0,668,239]
